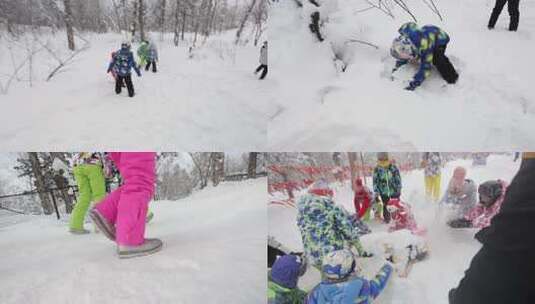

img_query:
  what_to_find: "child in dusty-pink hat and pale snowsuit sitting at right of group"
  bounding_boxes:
[440,167,477,218]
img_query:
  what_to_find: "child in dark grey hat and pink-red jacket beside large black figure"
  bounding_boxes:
[448,180,507,229]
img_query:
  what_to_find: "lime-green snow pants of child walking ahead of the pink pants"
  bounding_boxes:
[70,152,106,230]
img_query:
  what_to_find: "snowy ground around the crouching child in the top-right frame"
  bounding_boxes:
[268,0,535,151]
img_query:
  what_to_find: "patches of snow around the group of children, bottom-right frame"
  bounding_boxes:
[268,155,519,304]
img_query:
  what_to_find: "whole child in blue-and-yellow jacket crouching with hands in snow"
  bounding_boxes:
[390,22,459,91]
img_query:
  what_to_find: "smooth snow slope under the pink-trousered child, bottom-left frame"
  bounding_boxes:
[0,178,267,304]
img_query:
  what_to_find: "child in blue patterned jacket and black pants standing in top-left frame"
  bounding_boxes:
[108,48,141,97]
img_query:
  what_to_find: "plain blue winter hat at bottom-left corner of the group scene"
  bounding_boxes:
[271,254,302,288]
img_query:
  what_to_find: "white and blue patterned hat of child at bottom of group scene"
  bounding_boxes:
[322,249,356,280]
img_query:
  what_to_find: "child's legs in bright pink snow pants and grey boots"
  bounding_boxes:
[90,152,163,258]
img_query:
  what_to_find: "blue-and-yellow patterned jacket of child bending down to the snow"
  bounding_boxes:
[396,22,450,87]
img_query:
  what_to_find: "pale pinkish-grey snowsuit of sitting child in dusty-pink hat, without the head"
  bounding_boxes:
[440,179,477,218]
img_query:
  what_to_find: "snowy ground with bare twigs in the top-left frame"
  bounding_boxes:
[0,31,273,151]
